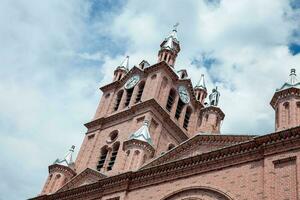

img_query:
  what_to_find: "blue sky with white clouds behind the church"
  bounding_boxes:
[0,0,300,200]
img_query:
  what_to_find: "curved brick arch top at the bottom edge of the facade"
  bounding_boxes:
[161,187,233,200]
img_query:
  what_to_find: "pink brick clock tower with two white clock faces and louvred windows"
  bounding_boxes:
[39,24,224,194]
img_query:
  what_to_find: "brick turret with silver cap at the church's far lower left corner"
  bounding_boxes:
[41,145,76,194]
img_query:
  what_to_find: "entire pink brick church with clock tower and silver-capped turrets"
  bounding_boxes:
[32,26,300,200]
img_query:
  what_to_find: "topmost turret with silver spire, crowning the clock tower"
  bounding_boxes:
[158,23,180,67]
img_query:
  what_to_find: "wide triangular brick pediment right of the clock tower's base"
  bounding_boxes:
[142,134,255,169]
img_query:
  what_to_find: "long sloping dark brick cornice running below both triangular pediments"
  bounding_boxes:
[33,127,300,199]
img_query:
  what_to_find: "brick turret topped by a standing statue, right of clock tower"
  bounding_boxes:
[199,87,225,134]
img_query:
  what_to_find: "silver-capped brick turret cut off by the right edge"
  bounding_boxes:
[270,69,300,131]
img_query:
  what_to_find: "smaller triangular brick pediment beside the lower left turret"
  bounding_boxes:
[58,168,107,191]
